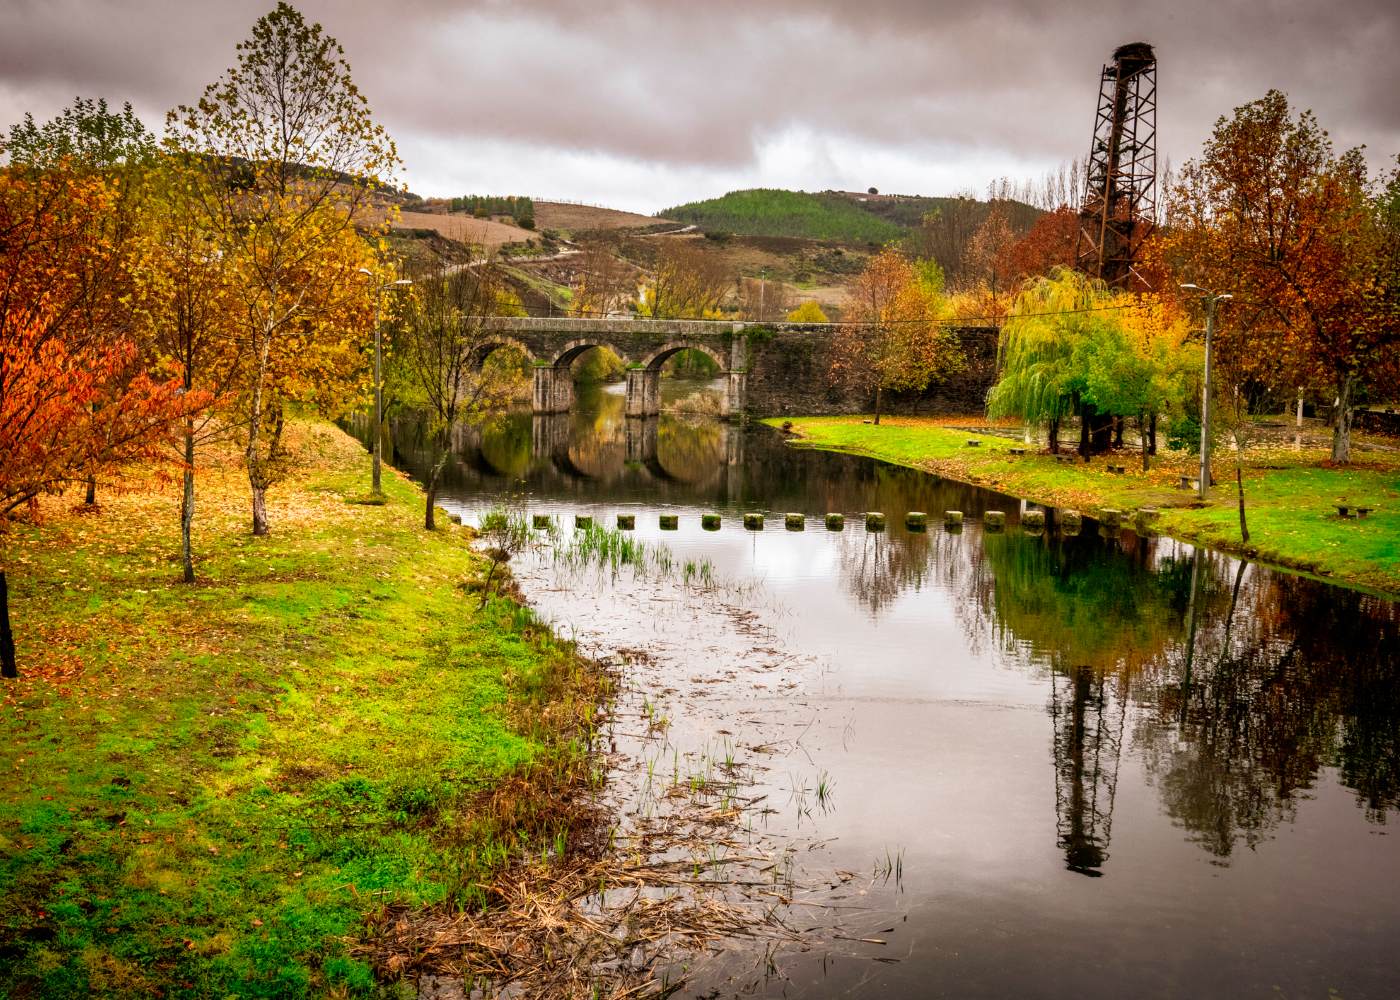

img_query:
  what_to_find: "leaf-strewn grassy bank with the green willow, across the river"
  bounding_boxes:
[764,416,1400,595]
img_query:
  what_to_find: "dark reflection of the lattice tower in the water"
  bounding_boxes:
[1050,667,1127,877]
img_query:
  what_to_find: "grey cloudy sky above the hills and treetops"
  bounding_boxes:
[0,0,1400,213]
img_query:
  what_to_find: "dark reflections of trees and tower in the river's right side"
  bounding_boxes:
[841,518,1400,874]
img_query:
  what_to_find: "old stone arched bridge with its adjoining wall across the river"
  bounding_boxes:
[475,317,997,417]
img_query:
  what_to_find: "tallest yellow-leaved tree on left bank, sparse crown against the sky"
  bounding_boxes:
[167,3,398,535]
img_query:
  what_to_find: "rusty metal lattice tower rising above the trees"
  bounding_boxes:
[1075,42,1156,289]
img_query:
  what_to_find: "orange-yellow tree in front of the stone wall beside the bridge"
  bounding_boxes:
[832,248,966,424]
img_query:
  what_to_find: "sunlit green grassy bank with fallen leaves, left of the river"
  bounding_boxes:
[0,424,592,997]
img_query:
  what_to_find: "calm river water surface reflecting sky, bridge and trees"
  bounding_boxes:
[378,385,1400,997]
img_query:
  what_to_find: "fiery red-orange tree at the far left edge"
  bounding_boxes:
[0,160,197,676]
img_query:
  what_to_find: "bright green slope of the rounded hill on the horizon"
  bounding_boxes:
[661,188,906,244]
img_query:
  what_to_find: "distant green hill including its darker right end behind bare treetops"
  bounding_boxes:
[658,188,1040,245]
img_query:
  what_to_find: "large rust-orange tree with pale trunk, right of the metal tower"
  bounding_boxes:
[1161,91,1400,462]
